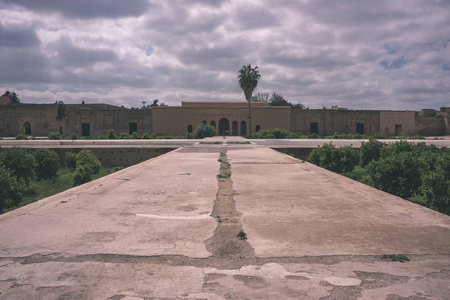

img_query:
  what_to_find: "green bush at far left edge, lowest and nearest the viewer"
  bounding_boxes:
[0,163,27,212]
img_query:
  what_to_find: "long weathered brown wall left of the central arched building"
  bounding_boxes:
[0,103,153,137]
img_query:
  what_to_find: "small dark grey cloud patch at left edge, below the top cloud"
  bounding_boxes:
[0,23,39,48]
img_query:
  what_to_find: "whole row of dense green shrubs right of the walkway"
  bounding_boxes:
[308,139,450,214]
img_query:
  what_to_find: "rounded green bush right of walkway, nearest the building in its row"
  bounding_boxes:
[308,143,359,174]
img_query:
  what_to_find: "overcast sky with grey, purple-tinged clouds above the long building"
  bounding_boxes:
[0,0,450,110]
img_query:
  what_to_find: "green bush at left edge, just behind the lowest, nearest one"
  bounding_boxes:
[0,147,36,186]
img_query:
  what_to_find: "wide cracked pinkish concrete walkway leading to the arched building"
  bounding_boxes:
[0,138,450,299]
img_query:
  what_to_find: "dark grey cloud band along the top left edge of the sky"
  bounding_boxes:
[2,0,150,19]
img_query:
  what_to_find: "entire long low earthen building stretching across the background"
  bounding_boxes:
[0,101,450,137]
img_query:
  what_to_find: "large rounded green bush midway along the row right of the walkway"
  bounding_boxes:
[367,152,421,199]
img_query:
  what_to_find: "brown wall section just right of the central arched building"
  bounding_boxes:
[291,109,380,136]
